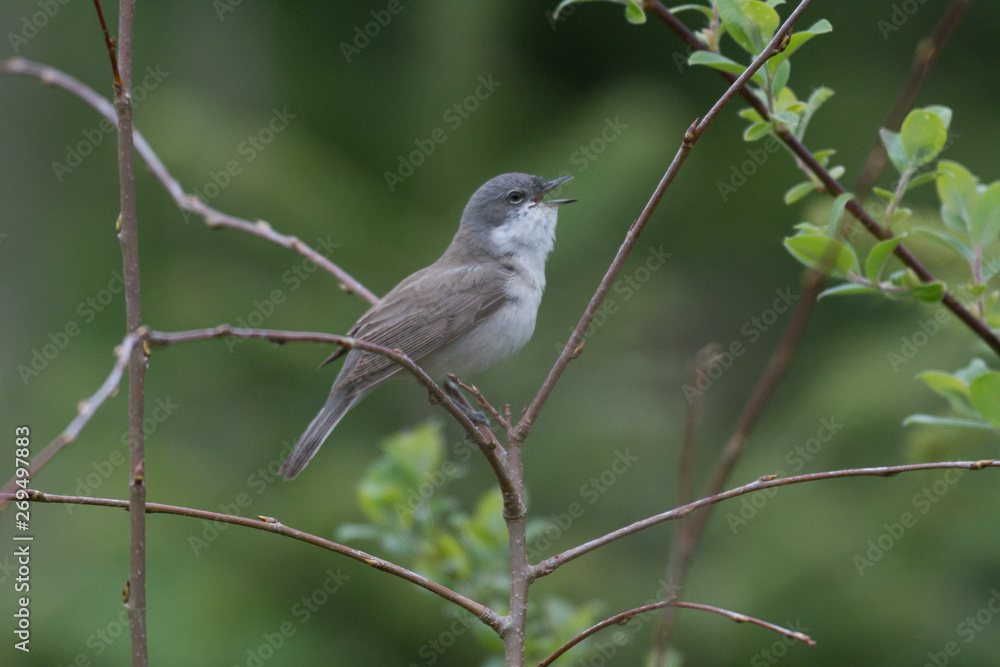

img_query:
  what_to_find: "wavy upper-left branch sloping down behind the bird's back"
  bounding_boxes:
[0,58,378,304]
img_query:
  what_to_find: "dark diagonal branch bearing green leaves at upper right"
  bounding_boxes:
[645,0,1000,356]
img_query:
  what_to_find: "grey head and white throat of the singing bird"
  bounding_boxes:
[456,173,576,264]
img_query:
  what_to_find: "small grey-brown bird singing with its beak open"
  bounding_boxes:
[281,173,576,479]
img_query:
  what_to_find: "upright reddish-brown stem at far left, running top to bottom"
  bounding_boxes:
[102,0,148,667]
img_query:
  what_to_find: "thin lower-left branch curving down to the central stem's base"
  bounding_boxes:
[0,489,503,630]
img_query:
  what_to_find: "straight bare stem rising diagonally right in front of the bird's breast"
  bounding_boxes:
[515,0,812,441]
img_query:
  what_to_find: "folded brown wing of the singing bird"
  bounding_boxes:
[324,258,509,386]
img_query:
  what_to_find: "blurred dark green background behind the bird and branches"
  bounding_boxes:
[0,1,1000,665]
